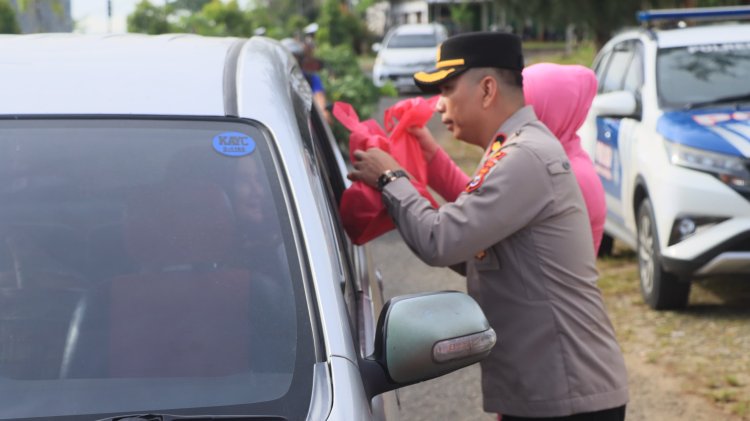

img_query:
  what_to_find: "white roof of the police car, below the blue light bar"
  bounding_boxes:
[656,24,750,48]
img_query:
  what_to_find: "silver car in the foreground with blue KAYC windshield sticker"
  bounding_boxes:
[0,34,495,421]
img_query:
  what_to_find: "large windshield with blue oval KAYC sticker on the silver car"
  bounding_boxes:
[0,119,315,419]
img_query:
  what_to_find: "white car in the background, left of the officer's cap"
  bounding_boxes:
[372,23,448,92]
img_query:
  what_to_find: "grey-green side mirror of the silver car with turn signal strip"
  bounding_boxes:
[360,291,496,398]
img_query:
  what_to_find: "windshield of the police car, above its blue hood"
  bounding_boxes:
[656,42,750,108]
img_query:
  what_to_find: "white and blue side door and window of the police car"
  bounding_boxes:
[593,40,643,243]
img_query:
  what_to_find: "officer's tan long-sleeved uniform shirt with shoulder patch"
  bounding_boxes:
[383,106,628,417]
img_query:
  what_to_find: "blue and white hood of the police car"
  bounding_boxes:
[656,107,750,157]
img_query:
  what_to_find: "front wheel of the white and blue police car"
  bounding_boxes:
[637,199,690,310]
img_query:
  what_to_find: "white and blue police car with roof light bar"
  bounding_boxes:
[580,7,750,309]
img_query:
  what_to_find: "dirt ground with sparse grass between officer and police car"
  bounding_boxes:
[598,247,750,421]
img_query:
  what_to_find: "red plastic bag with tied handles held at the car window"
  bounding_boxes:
[333,96,439,244]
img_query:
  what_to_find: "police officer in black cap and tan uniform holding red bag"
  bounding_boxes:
[350,32,628,421]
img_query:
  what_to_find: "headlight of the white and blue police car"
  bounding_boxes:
[665,142,750,190]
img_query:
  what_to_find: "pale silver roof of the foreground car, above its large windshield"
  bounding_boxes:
[0,34,296,116]
